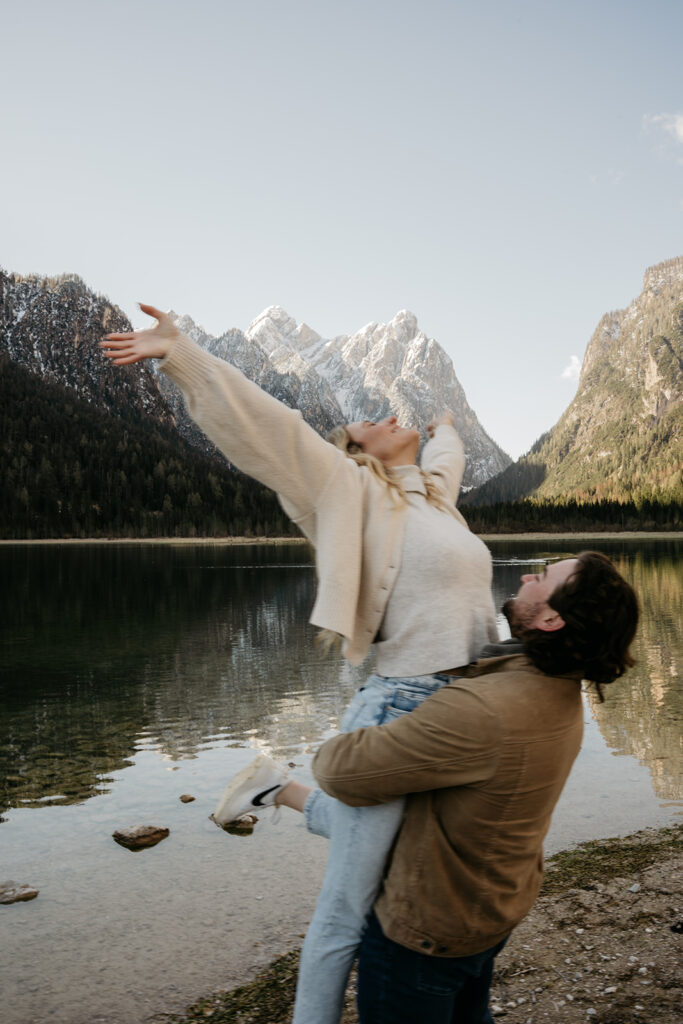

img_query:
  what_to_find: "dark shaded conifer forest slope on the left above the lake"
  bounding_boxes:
[0,355,298,540]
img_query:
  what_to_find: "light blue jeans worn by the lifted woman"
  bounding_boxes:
[293,675,453,1024]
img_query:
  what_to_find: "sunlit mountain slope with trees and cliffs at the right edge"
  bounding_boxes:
[467,258,683,505]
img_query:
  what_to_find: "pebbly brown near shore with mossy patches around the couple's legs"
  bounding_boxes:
[163,825,683,1024]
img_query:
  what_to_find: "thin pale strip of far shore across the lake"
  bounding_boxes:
[0,530,683,547]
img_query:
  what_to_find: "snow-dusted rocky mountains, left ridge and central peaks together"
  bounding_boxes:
[0,270,510,486]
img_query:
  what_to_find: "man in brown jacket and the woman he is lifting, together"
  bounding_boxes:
[101,306,638,1024]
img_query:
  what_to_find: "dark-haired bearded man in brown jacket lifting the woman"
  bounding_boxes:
[313,552,638,1024]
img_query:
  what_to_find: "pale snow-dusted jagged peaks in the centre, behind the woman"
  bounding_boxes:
[169,306,510,487]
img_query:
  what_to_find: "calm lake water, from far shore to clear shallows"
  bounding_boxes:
[0,538,683,1024]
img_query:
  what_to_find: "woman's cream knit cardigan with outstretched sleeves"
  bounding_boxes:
[161,334,465,665]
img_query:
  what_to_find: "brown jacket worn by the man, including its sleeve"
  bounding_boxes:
[313,654,583,956]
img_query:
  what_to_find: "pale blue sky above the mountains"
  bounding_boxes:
[0,0,683,456]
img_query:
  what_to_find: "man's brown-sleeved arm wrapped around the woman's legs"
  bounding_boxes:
[313,683,501,807]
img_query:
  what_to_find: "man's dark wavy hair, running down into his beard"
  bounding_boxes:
[518,551,638,700]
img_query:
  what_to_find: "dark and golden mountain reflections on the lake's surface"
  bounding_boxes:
[0,538,683,810]
